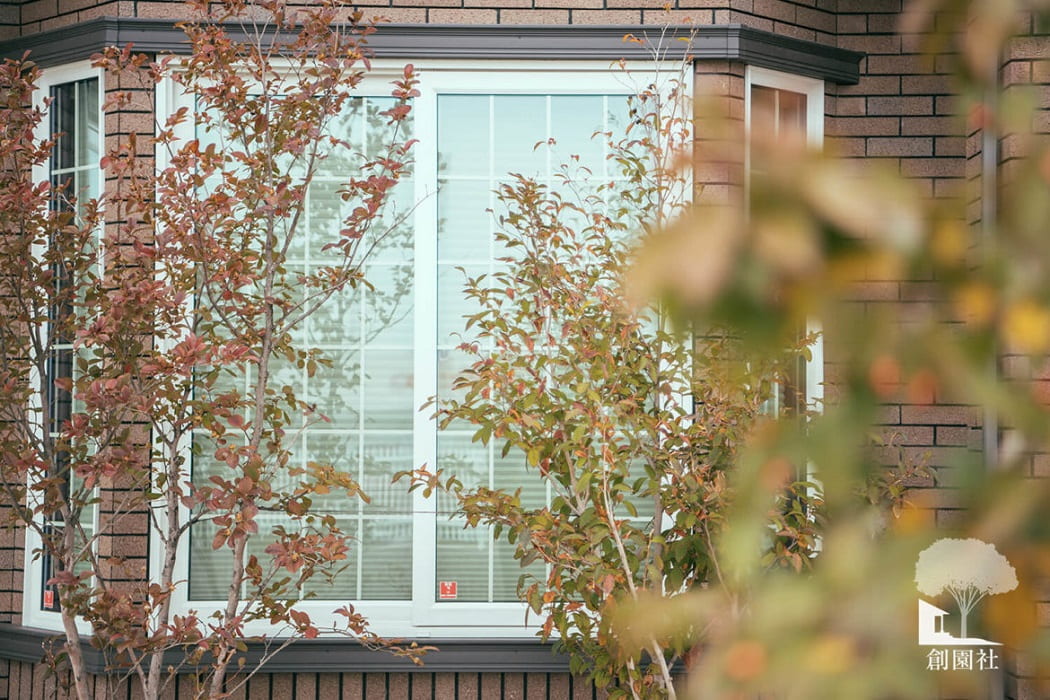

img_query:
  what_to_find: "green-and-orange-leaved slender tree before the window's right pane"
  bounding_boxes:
[401,46,819,698]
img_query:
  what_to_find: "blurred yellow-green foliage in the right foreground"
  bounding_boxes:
[623,0,1050,699]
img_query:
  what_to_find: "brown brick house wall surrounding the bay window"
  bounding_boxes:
[0,0,1050,699]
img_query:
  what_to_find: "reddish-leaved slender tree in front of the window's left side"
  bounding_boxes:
[0,0,418,698]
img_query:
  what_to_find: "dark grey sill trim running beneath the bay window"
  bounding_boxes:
[0,624,569,674]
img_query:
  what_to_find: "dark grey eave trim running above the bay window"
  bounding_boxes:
[0,17,864,84]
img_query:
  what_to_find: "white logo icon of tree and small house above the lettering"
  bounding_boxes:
[916,537,1017,646]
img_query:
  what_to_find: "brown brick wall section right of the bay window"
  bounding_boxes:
[826,0,981,526]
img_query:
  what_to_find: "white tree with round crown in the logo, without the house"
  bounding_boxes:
[916,537,1017,637]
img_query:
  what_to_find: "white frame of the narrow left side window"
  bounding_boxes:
[22,61,106,634]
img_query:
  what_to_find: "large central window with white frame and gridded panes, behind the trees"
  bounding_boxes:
[166,67,629,637]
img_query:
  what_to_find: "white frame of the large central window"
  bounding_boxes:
[150,60,684,638]
